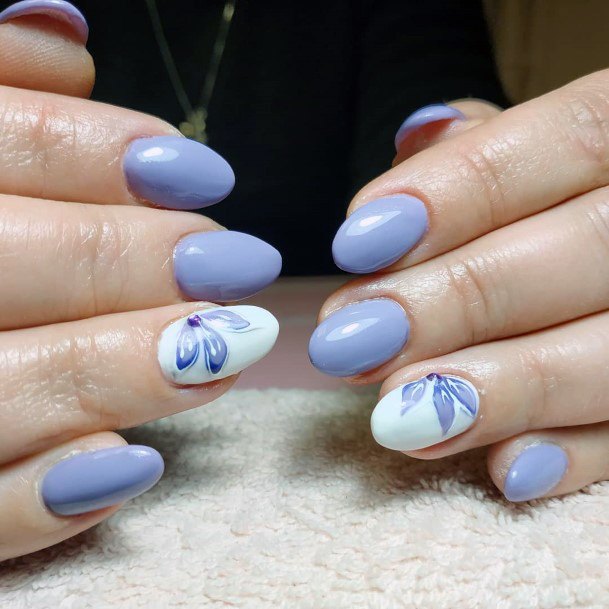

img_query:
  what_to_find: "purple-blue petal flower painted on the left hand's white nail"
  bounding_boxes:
[176,310,251,374]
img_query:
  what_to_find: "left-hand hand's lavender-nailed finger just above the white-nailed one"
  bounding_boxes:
[0,195,281,330]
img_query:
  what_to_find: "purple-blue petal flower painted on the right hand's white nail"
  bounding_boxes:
[400,373,478,437]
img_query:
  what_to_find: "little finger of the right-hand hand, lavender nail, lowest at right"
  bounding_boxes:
[488,422,609,501]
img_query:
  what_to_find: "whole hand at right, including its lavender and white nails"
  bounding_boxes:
[310,71,609,501]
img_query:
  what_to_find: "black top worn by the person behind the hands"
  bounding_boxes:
[76,0,505,275]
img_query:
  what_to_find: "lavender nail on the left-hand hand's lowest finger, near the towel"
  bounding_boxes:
[41,446,164,516]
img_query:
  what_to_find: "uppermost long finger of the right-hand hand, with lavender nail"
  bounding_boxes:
[335,66,609,272]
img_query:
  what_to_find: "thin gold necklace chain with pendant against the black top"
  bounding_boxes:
[146,0,237,144]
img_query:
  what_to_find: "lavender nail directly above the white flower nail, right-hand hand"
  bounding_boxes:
[309,298,410,376]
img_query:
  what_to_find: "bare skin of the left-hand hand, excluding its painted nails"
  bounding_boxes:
[0,11,242,560]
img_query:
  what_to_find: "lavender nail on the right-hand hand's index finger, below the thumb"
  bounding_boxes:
[332,195,428,273]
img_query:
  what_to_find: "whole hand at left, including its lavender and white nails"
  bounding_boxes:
[0,2,281,559]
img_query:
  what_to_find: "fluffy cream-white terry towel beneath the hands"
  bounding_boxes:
[0,389,609,609]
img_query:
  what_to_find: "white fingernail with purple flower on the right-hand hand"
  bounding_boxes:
[370,374,480,451]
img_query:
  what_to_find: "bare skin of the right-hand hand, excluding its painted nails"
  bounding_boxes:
[320,76,609,496]
